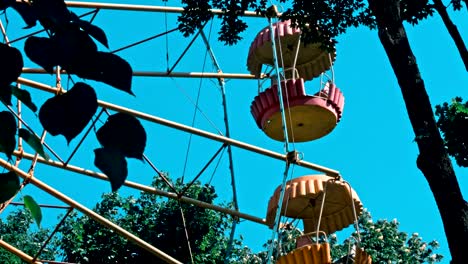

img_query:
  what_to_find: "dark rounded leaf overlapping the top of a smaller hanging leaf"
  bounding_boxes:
[97,113,146,160]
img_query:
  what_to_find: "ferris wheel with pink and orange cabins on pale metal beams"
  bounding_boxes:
[0,2,372,263]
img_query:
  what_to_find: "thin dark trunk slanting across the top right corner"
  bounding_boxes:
[433,0,468,71]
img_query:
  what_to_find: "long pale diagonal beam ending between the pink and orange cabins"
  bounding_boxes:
[17,77,341,177]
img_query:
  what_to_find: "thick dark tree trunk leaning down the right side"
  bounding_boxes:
[369,0,468,264]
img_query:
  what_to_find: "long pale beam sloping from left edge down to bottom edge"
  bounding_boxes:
[0,159,182,264]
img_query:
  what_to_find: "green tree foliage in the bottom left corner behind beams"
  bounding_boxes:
[0,208,56,264]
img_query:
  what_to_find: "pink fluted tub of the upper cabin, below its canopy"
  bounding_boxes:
[250,78,344,142]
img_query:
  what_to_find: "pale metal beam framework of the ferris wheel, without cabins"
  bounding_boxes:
[0,0,340,263]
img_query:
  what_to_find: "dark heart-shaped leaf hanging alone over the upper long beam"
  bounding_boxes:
[39,82,98,143]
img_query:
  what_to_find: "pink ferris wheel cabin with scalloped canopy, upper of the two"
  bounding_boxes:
[247,21,344,142]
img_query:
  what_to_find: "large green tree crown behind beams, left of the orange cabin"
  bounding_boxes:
[55,175,240,264]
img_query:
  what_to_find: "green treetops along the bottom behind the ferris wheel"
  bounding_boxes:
[0,179,442,264]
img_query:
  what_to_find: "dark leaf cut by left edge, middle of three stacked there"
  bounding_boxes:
[0,111,16,160]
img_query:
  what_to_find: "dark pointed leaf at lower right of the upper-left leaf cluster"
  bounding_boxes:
[70,51,134,95]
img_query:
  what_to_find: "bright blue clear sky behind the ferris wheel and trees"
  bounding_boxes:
[2,1,468,263]
